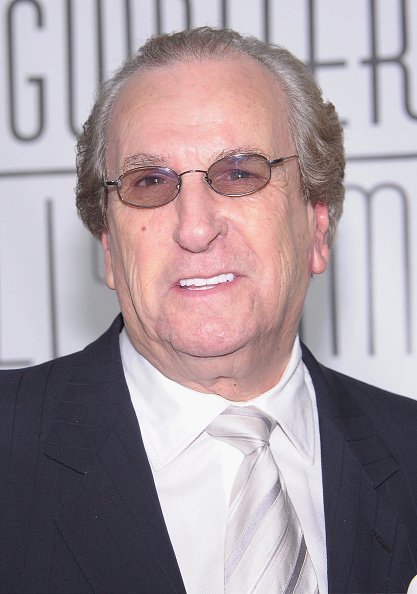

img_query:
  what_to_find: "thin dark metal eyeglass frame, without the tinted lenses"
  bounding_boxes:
[103,153,298,208]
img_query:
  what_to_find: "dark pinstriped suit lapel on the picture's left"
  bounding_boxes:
[44,319,185,594]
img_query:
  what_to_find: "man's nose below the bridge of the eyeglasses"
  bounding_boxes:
[173,170,228,253]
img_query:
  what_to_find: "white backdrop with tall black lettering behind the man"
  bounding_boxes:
[0,0,417,398]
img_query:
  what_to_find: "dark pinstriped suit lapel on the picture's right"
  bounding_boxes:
[304,342,407,592]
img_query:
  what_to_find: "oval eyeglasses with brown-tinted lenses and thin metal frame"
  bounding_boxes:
[104,153,298,208]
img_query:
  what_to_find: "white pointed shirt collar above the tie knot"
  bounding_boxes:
[120,330,314,471]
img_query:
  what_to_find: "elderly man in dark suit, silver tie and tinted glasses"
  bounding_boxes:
[0,28,417,594]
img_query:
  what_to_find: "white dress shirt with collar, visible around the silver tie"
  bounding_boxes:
[120,330,327,594]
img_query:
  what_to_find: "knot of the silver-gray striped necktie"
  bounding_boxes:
[206,406,276,455]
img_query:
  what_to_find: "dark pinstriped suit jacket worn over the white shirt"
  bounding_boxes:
[0,317,417,594]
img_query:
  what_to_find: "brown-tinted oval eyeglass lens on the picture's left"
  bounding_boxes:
[119,167,179,208]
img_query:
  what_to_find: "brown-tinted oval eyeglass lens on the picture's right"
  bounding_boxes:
[207,154,271,196]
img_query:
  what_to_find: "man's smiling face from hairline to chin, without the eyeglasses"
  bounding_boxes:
[102,57,327,380]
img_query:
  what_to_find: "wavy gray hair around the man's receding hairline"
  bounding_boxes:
[76,27,345,243]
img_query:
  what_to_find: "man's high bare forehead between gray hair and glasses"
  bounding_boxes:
[108,56,293,167]
